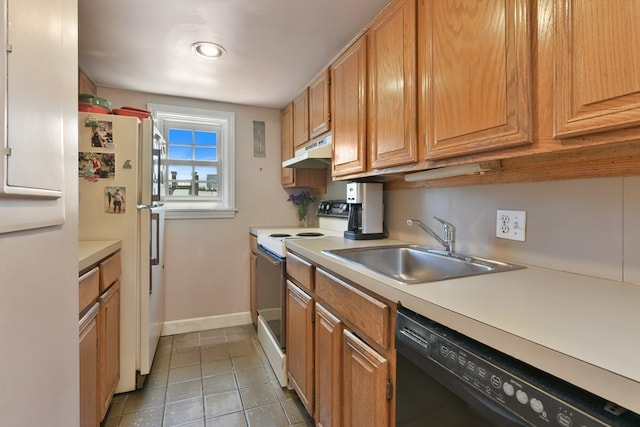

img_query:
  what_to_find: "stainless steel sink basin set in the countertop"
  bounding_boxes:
[322,245,525,285]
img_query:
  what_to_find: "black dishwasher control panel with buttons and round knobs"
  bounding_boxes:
[395,308,640,427]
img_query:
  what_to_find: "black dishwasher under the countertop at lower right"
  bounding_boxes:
[395,308,640,427]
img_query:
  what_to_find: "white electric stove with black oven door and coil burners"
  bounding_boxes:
[256,201,349,387]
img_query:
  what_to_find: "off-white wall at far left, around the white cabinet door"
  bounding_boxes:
[0,0,80,427]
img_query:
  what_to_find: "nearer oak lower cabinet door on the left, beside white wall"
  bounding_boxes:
[79,303,100,427]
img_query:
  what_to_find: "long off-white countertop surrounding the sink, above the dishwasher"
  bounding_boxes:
[286,237,640,413]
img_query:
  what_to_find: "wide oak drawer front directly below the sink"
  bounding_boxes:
[316,270,391,349]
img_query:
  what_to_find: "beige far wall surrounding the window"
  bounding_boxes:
[99,88,328,321]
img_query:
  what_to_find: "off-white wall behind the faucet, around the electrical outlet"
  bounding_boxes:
[385,177,640,283]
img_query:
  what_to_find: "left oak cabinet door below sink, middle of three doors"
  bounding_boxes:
[315,304,343,427]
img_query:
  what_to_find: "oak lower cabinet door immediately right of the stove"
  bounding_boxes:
[286,281,314,416]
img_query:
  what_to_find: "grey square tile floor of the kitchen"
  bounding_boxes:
[102,325,314,427]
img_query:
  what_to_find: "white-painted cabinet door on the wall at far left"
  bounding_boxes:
[0,0,64,198]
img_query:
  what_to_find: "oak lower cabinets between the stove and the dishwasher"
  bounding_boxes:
[286,254,395,427]
